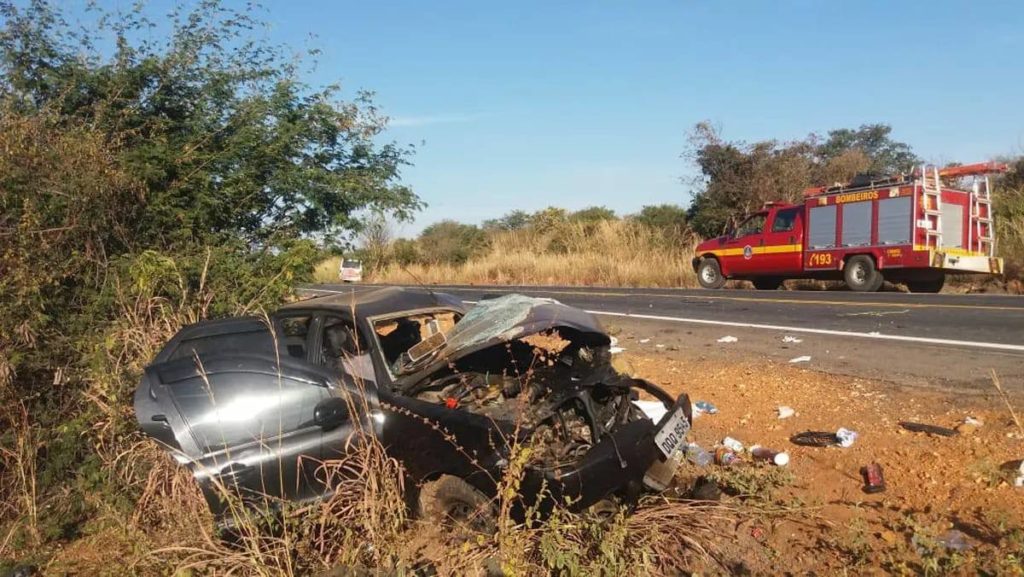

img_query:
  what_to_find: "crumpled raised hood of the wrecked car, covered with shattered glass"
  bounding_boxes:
[399,294,610,382]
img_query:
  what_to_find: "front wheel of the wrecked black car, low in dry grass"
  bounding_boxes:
[418,475,495,533]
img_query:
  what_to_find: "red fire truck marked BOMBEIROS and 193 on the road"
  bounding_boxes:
[693,162,1008,292]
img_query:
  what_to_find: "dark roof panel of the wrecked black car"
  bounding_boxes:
[281,286,465,317]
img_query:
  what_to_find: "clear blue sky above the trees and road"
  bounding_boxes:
[108,0,1024,235]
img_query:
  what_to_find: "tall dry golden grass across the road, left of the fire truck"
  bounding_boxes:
[373,220,696,287]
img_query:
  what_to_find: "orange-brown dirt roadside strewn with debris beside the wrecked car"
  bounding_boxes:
[615,332,1024,575]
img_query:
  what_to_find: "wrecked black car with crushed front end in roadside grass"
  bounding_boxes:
[135,287,691,514]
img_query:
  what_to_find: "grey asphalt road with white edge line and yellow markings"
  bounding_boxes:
[309,285,1024,391]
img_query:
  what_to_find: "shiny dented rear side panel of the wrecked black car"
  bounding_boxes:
[136,356,331,513]
